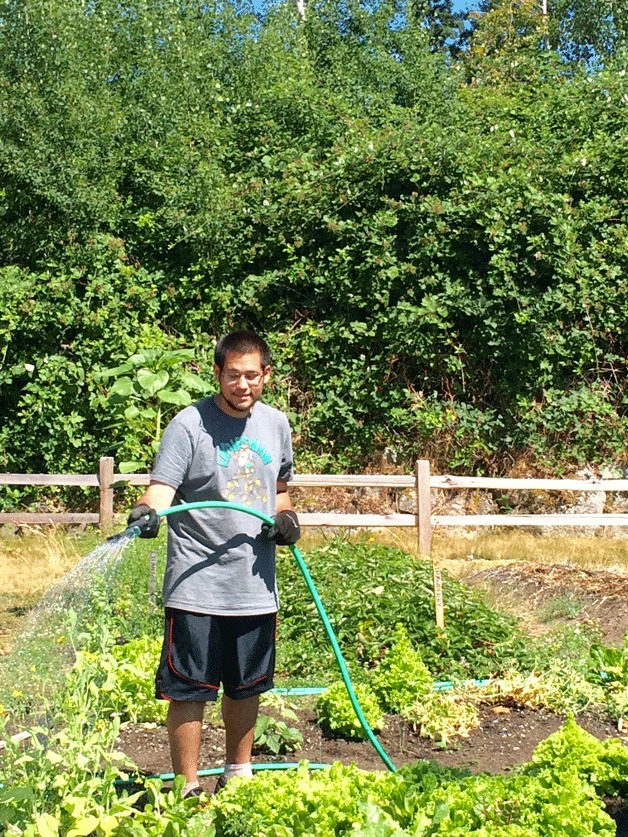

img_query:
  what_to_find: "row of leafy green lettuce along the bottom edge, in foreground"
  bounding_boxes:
[201,740,615,837]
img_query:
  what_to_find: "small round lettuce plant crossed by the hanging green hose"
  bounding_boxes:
[316,680,385,739]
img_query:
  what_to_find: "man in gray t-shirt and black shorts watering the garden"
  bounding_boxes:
[129,331,300,796]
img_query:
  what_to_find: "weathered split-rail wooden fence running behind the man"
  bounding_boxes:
[0,457,628,626]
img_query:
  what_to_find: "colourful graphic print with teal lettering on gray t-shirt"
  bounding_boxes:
[218,435,273,505]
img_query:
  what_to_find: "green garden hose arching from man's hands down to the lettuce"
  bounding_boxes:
[150,500,397,773]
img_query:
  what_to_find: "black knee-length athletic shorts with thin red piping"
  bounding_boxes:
[155,608,277,702]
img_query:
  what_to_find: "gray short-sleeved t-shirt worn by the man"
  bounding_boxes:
[151,397,292,616]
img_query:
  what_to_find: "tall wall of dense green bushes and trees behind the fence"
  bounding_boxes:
[0,0,628,476]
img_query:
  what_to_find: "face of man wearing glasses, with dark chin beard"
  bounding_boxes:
[214,352,270,418]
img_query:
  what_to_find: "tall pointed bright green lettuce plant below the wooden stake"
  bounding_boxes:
[369,624,433,715]
